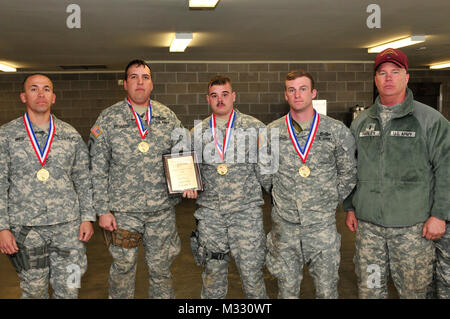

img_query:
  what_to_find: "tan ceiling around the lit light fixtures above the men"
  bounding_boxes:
[0,0,450,71]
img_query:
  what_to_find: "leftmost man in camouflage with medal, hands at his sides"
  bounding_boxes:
[0,74,95,298]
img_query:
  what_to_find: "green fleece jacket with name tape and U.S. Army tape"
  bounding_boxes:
[344,89,450,227]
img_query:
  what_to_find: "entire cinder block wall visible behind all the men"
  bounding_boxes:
[0,63,450,141]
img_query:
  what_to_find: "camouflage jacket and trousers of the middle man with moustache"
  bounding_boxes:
[194,110,270,299]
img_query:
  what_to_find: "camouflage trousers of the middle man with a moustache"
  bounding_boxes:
[196,207,267,299]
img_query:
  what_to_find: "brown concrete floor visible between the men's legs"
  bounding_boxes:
[0,195,397,299]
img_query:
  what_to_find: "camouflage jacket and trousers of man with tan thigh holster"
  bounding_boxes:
[88,99,185,298]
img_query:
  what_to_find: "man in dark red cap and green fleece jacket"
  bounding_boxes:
[344,49,450,298]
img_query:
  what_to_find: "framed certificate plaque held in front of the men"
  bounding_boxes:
[163,151,203,194]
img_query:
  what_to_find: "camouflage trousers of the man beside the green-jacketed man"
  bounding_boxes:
[266,207,341,299]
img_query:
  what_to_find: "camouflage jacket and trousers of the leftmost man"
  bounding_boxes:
[0,117,95,298]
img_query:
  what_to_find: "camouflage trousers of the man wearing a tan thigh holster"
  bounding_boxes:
[109,208,181,299]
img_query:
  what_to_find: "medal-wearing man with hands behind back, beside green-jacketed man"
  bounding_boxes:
[266,70,356,298]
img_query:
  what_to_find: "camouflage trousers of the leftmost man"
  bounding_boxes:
[11,221,87,299]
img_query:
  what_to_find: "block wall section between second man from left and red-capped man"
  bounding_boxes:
[151,63,373,128]
